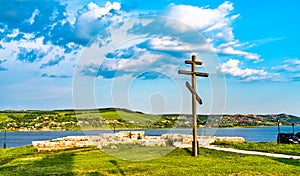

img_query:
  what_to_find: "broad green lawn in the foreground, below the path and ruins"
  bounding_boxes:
[0,147,300,175]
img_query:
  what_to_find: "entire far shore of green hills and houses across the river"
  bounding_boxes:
[0,108,300,131]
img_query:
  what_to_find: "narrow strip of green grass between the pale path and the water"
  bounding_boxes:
[215,142,300,156]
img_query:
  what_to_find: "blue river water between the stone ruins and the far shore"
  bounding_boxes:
[0,126,300,148]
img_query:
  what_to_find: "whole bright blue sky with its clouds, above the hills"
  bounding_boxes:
[0,0,300,115]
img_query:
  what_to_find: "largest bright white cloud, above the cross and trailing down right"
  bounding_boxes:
[165,1,260,62]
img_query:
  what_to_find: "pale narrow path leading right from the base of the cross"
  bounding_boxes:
[201,145,300,160]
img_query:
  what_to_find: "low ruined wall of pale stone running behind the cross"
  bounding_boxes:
[32,131,245,151]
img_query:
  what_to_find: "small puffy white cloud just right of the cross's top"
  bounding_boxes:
[220,59,268,80]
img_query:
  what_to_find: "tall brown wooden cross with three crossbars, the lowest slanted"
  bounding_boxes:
[178,55,208,156]
